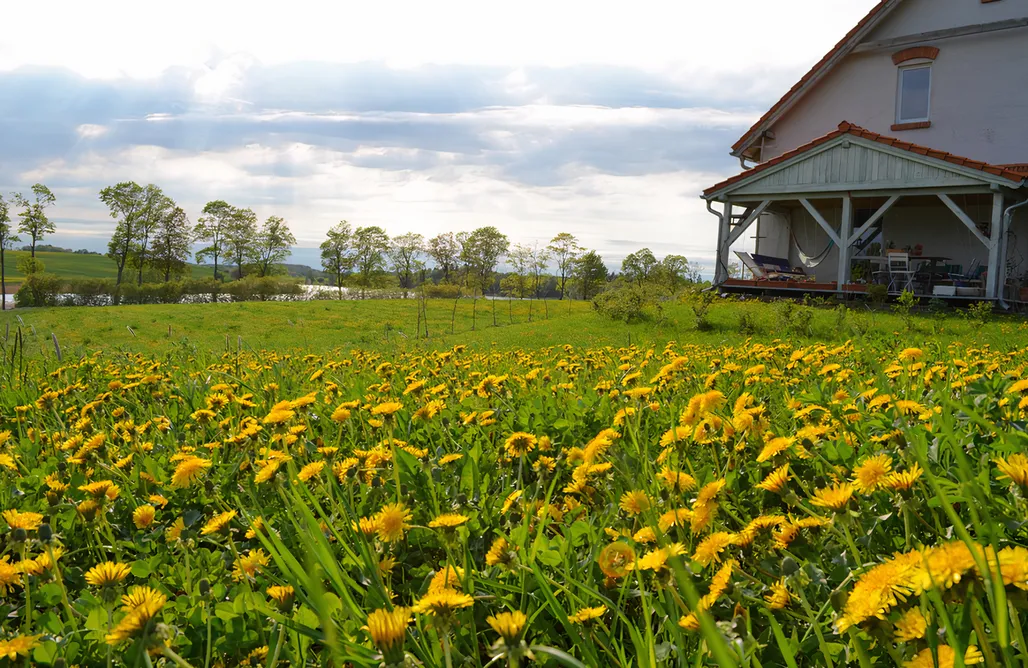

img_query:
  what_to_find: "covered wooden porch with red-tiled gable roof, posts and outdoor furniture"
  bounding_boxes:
[703,123,1028,301]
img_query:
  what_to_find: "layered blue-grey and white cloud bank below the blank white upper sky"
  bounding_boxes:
[0,57,761,266]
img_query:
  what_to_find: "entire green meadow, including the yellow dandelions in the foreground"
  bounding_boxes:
[0,300,1028,668]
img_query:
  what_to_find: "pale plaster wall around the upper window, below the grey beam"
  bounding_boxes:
[762,27,1028,164]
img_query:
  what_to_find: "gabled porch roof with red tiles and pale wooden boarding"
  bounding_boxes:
[703,121,1028,199]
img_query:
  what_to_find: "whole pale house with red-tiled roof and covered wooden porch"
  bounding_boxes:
[703,0,1028,300]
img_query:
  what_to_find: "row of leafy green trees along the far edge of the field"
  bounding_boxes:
[0,181,700,308]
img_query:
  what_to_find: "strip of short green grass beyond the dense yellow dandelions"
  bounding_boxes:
[0,299,1028,354]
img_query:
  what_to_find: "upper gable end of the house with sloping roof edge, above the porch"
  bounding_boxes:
[732,0,1028,162]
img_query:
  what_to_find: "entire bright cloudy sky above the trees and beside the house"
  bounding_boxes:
[0,0,875,268]
